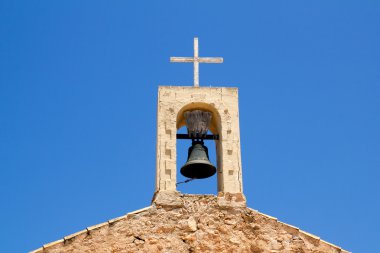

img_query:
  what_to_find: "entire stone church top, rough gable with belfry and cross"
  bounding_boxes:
[32,38,347,253]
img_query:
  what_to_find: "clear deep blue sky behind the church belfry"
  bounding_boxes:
[0,0,380,253]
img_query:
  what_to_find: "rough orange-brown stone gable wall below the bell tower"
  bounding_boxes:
[32,194,347,253]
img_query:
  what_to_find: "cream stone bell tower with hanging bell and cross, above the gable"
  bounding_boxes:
[153,38,245,206]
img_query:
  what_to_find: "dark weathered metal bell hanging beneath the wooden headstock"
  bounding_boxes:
[181,141,216,179]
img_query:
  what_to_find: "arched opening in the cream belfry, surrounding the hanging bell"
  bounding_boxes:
[176,102,221,194]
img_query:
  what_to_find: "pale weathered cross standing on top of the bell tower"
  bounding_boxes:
[170,38,223,87]
